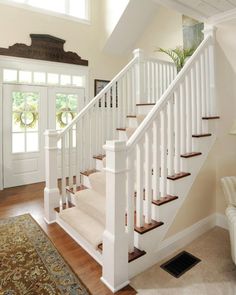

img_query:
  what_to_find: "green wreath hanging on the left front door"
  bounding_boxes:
[14,105,39,129]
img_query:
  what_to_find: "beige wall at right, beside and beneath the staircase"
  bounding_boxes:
[167,22,236,237]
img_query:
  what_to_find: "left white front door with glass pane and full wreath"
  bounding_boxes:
[3,85,48,188]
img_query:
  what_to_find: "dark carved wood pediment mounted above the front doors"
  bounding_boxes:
[0,34,88,66]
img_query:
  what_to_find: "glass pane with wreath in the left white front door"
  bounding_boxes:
[12,91,39,153]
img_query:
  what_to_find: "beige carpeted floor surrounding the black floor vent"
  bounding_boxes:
[131,227,236,295]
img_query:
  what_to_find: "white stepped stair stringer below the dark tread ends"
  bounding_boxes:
[129,133,216,278]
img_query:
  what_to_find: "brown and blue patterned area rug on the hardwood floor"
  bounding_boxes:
[0,214,90,295]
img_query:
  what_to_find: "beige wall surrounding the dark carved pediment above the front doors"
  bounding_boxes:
[0,0,127,96]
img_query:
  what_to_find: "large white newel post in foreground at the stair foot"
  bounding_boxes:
[101,141,129,292]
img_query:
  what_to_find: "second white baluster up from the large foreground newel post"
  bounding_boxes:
[136,143,144,227]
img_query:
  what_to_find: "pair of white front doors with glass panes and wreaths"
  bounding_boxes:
[3,85,85,188]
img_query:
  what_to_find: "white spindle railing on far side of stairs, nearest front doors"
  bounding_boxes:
[43,49,174,222]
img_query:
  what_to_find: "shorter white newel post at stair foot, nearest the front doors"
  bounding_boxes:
[44,130,59,223]
